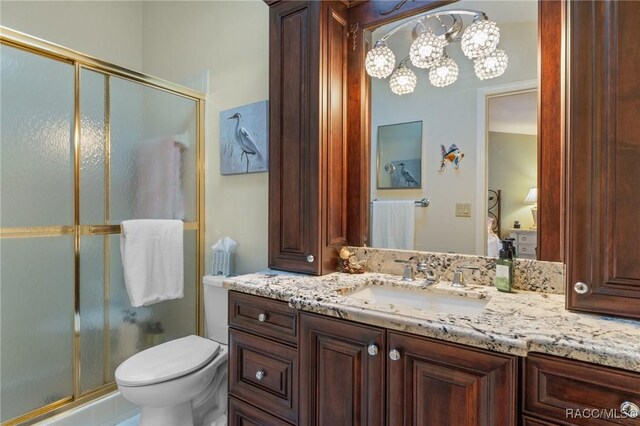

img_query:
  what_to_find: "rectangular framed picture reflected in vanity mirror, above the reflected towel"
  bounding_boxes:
[377,121,422,189]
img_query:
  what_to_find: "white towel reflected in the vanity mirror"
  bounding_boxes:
[371,200,416,250]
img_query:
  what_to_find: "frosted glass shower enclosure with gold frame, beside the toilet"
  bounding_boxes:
[0,27,204,424]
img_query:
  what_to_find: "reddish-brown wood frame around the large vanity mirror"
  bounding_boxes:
[347,0,564,261]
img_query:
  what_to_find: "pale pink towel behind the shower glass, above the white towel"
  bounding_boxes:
[134,138,184,219]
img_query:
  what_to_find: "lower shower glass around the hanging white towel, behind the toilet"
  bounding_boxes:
[108,231,197,380]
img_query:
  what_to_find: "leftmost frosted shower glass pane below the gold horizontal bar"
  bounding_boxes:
[0,236,74,421]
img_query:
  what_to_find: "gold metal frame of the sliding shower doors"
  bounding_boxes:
[0,26,206,426]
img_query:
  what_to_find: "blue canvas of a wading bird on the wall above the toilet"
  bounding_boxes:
[220,101,269,175]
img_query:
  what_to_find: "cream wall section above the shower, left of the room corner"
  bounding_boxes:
[0,0,142,70]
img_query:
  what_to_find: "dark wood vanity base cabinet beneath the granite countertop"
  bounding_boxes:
[229,291,640,426]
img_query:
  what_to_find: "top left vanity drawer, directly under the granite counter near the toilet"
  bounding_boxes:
[229,291,297,345]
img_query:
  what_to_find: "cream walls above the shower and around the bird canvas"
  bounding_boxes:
[0,0,269,273]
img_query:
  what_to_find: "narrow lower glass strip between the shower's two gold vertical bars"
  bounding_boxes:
[80,236,108,393]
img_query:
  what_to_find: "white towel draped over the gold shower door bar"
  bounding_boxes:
[120,219,184,307]
